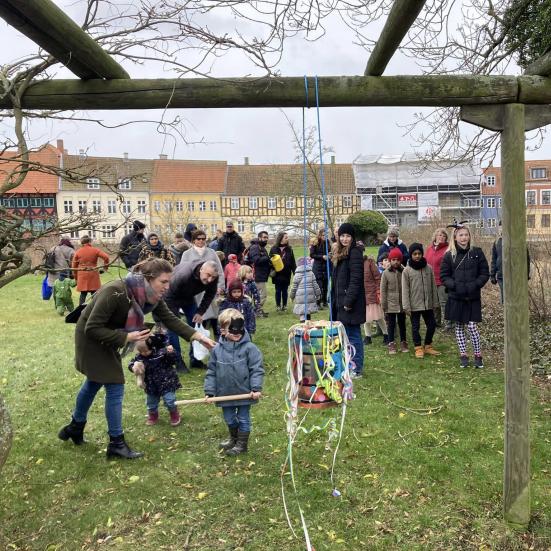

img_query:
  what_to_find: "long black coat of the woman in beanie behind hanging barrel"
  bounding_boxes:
[331,245,365,325]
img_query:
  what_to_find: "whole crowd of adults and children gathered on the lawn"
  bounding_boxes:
[48,221,499,458]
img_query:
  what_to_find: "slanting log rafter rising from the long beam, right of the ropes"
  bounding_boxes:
[364,0,427,77]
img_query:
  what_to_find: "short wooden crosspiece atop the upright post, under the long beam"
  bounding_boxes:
[460,105,551,131]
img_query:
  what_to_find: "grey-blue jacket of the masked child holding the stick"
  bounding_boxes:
[204,332,264,407]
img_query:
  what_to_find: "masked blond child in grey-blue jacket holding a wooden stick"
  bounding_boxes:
[204,308,264,455]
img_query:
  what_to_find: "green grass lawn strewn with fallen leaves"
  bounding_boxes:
[0,276,551,551]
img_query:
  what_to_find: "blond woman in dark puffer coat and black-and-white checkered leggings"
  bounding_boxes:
[440,226,490,368]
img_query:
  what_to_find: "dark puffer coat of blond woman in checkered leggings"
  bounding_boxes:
[440,247,490,323]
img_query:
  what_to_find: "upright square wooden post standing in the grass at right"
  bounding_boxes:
[501,103,530,526]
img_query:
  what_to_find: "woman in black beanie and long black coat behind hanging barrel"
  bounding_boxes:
[331,224,365,377]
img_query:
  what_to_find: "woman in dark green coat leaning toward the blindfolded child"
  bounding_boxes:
[59,258,216,459]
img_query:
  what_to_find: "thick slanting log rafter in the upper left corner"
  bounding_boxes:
[0,0,130,79]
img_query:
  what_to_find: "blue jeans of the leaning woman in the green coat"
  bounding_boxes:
[73,379,124,436]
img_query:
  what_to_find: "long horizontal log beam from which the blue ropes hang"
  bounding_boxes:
[0,75,536,110]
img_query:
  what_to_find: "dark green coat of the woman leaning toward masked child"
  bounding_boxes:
[75,280,195,384]
